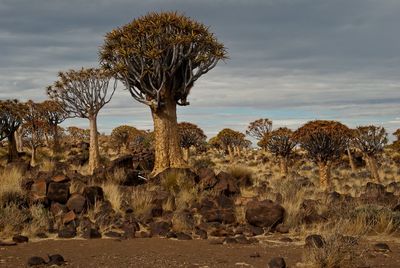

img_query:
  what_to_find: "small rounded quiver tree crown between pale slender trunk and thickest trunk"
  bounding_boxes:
[111,125,143,153]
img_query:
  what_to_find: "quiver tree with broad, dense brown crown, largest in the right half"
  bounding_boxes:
[293,120,351,190]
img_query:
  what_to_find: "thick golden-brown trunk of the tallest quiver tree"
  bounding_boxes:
[151,98,187,176]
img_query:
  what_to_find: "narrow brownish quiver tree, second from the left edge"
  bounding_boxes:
[22,100,50,167]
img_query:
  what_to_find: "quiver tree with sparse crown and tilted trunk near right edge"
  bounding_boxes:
[352,126,388,182]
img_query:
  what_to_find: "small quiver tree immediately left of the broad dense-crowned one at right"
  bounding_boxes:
[263,127,297,176]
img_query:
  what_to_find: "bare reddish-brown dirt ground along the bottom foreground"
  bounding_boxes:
[0,238,400,268]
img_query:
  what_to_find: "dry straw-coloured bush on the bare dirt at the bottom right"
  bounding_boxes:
[303,232,359,268]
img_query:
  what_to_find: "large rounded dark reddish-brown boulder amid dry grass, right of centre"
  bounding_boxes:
[245,199,285,228]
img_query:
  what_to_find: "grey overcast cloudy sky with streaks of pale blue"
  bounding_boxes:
[0,0,400,141]
